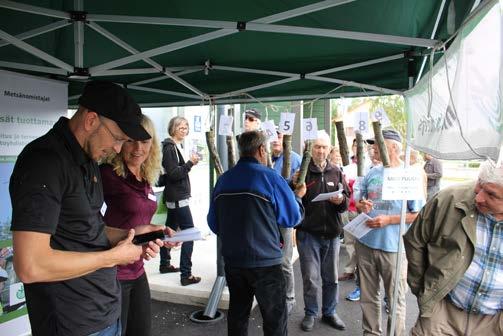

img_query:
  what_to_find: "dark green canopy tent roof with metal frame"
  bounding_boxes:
[0,0,480,106]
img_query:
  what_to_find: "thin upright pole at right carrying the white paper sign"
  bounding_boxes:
[389,77,414,336]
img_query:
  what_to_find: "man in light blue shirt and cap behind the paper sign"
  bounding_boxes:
[355,129,422,336]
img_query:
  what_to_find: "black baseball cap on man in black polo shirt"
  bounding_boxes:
[79,81,151,141]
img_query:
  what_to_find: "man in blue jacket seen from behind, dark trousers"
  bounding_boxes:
[208,131,306,336]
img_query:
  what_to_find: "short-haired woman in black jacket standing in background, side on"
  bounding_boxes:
[159,117,201,286]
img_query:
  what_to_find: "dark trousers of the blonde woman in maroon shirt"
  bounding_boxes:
[120,273,152,336]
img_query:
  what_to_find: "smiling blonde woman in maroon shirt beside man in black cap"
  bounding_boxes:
[100,116,172,336]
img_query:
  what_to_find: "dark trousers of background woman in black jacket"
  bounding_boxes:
[160,206,194,278]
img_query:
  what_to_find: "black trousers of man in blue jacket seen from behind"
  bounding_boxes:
[225,265,288,336]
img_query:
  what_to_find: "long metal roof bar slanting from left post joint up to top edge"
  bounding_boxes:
[89,0,355,72]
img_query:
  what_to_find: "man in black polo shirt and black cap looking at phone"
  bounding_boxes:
[9,81,162,335]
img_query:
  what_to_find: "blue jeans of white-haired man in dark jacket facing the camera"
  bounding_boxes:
[297,230,340,316]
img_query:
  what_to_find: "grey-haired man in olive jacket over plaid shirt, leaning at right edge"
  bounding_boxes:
[404,161,503,336]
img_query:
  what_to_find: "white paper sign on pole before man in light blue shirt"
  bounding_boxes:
[382,167,424,200]
